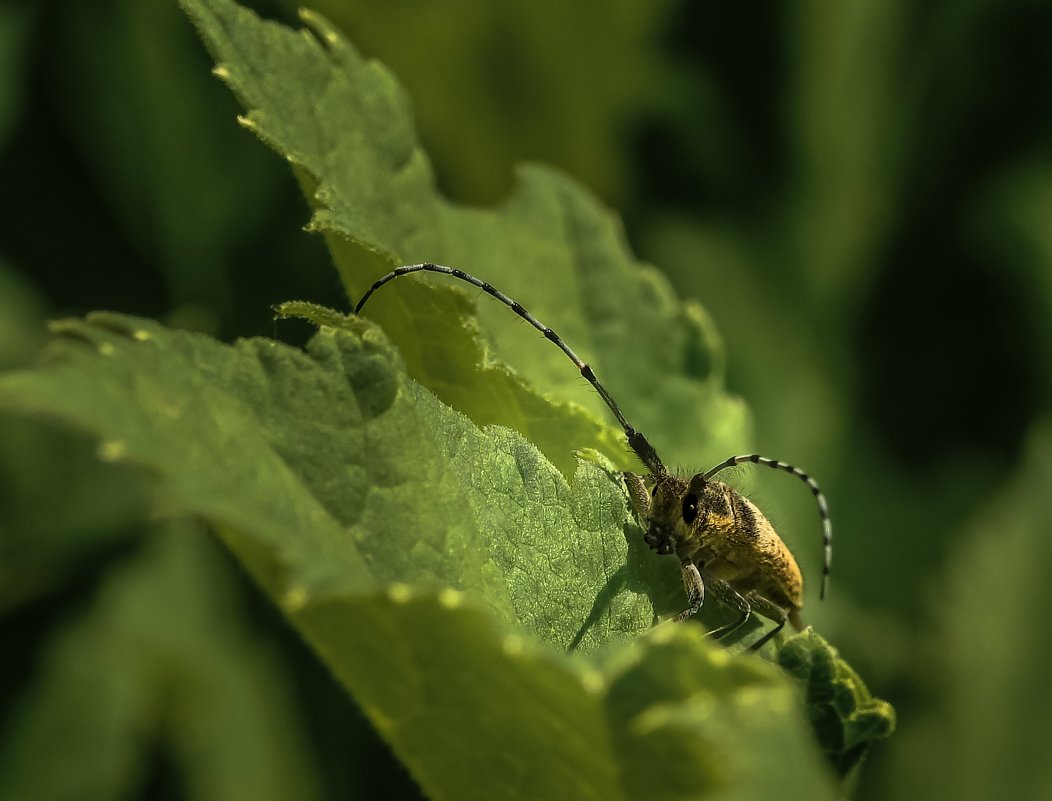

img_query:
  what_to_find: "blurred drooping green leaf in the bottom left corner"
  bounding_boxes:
[0,517,319,801]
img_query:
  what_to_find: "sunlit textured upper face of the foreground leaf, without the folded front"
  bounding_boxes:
[0,314,656,647]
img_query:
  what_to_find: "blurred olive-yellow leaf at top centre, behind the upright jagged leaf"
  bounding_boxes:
[285,0,673,206]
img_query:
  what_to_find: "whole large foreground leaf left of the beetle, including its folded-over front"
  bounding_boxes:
[0,314,831,799]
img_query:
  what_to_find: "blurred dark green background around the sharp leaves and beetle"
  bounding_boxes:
[0,0,1052,799]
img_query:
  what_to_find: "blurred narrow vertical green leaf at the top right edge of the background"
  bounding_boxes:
[791,0,915,311]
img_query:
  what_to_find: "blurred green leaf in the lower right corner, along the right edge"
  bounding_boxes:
[884,419,1052,801]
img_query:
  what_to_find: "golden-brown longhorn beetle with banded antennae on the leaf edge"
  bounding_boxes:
[355,264,833,650]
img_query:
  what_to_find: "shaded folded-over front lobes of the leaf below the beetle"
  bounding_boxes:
[299,594,833,800]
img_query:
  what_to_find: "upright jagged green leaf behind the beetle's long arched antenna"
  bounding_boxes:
[184,0,746,476]
